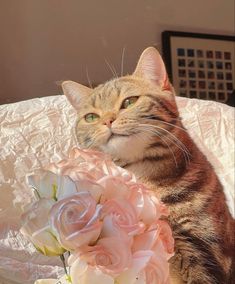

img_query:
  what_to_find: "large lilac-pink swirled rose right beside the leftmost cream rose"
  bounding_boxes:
[50,192,102,250]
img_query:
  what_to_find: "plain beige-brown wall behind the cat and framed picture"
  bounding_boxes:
[0,0,234,103]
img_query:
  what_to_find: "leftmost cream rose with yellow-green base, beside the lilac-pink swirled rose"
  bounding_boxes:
[20,198,65,256]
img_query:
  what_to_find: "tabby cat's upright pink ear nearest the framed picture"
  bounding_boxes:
[133,47,172,90]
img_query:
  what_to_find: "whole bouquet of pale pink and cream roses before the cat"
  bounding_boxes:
[21,148,174,284]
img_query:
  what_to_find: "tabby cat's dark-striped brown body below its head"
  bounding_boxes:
[125,113,235,284]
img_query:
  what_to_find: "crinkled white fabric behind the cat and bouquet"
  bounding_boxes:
[0,96,235,284]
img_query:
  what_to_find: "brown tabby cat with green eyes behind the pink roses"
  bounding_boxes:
[62,47,235,284]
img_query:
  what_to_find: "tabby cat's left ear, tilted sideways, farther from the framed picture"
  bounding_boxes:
[61,81,92,109]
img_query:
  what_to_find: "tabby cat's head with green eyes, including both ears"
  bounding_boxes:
[62,47,178,162]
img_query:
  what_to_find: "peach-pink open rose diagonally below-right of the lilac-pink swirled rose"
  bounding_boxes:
[80,237,132,276]
